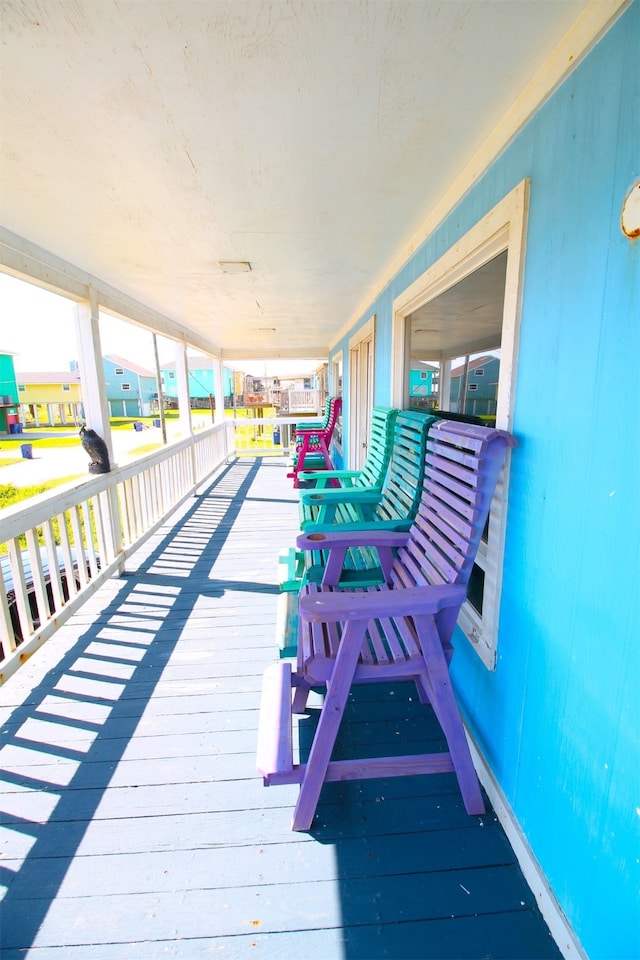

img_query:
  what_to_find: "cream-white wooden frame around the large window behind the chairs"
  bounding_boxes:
[391,180,529,670]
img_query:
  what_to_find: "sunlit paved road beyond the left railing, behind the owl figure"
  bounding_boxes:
[0,421,208,487]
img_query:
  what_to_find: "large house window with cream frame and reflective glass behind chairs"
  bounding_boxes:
[391,181,528,670]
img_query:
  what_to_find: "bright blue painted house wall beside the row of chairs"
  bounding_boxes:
[330,0,640,960]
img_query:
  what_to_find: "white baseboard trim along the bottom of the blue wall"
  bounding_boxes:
[467,730,588,960]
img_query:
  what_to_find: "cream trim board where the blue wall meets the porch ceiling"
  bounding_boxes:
[330,0,633,349]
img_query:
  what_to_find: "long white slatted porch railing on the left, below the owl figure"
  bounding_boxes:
[0,421,234,683]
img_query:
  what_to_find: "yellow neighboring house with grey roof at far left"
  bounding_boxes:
[16,370,83,427]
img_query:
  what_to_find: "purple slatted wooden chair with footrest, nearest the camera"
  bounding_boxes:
[258,420,515,830]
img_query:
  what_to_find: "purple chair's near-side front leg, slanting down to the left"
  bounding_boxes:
[291,621,366,830]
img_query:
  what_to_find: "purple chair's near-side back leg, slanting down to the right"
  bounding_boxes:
[415,617,485,814]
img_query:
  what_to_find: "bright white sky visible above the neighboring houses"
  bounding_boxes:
[0,273,318,377]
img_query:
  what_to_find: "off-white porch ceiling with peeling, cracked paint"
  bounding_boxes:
[0,0,596,359]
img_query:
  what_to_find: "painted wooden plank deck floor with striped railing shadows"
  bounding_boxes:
[0,458,560,960]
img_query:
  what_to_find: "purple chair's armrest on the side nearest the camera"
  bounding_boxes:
[298,584,467,623]
